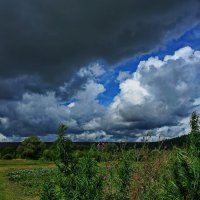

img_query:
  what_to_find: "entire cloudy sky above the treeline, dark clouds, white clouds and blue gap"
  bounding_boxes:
[0,0,200,142]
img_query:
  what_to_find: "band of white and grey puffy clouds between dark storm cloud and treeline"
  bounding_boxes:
[0,47,200,141]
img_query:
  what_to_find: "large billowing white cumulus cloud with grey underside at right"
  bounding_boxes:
[104,47,200,137]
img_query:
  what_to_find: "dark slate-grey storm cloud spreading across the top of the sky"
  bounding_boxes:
[0,0,200,81]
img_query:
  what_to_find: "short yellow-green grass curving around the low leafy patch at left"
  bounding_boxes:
[0,159,54,200]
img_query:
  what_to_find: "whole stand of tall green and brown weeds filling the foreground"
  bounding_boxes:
[41,113,200,200]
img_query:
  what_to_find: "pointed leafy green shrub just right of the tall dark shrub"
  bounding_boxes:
[65,149,103,200]
